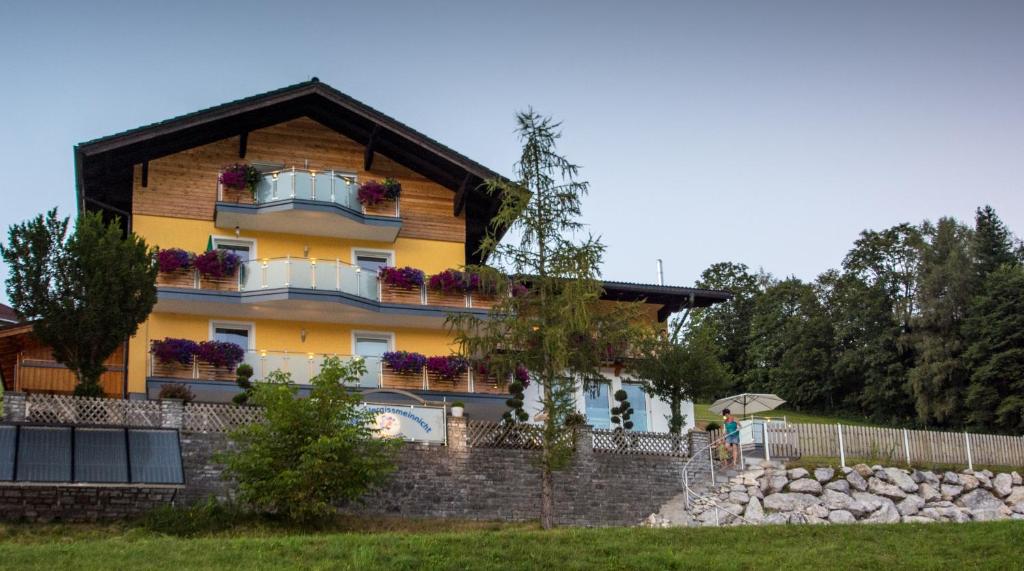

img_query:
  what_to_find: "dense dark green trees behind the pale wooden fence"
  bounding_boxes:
[689,206,1024,433]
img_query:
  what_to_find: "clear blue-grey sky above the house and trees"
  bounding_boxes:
[0,0,1024,304]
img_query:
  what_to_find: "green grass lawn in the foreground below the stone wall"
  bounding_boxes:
[0,522,1024,571]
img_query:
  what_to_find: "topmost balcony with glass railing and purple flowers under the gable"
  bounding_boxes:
[216,167,401,241]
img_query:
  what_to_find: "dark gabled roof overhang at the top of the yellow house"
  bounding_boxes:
[75,79,512,263]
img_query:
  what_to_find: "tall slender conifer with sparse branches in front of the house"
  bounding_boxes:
[449,109,639,529]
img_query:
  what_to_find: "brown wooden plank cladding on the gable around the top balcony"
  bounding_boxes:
[132,118,466,243]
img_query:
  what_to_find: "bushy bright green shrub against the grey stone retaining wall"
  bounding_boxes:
[218,357,401,523]
